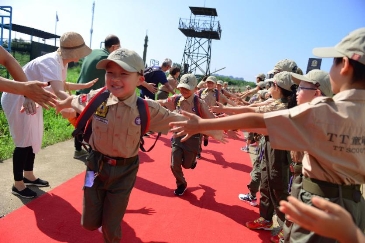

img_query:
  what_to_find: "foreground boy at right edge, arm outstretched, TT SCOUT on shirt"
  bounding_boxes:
[170,28,365,242]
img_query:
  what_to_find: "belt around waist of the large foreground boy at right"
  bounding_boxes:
[303,177,362,202]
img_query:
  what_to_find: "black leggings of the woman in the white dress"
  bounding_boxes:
[13,146,35,181]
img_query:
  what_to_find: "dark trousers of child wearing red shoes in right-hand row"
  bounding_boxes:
[260,138,289,225]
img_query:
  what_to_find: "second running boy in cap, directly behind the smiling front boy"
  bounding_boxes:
[159,74,214,196]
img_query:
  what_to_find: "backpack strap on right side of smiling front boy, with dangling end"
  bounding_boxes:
[137,97,161,152]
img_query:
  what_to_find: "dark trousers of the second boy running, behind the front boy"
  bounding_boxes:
[170,135,200,186]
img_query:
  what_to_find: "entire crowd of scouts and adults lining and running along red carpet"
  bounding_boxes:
[0,28,365,242]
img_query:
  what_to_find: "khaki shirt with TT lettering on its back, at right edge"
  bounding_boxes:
[264,89,365,185]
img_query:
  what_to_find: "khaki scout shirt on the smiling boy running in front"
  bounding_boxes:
[72,90,186,158]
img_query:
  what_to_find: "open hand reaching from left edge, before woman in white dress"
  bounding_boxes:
[23,81,57,109]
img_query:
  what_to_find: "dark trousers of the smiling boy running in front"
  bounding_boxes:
[81,153,139,243]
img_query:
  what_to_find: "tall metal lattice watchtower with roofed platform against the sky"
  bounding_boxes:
[179,7,222,75]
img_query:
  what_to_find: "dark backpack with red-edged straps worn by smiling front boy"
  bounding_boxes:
[72,87,161,152]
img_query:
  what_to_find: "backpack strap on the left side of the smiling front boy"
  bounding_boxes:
[72,87,110,137]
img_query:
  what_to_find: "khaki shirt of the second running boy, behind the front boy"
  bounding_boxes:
[162,94,215,118]
